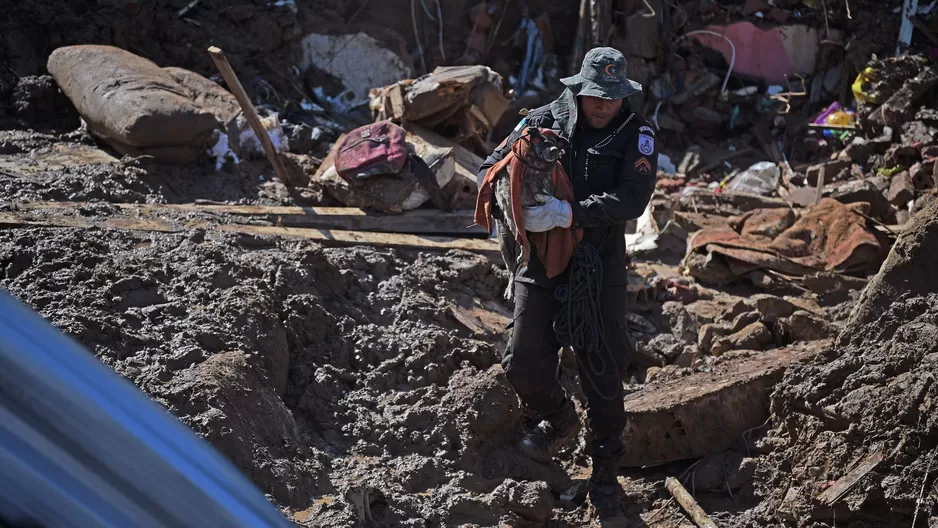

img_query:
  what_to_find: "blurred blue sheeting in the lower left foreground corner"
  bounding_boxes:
[0,291,291,528]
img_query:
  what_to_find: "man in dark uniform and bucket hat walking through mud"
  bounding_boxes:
[479,48,658,526]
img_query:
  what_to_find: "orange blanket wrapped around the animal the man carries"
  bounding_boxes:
[475,128,583,278]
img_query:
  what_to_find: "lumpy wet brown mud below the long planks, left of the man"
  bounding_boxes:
[0,225,584,526]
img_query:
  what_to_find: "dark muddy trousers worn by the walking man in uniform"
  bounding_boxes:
[502,281,633,460]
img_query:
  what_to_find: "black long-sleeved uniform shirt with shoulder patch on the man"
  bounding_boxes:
[479,90,658,287]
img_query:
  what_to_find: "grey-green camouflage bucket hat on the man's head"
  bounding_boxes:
[560,47,642,99]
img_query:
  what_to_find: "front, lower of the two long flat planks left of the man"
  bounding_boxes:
[0,213,500,258]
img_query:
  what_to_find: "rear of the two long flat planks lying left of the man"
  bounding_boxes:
[16,202,488,237]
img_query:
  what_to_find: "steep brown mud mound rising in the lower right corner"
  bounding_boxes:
[744,200,938,526]
